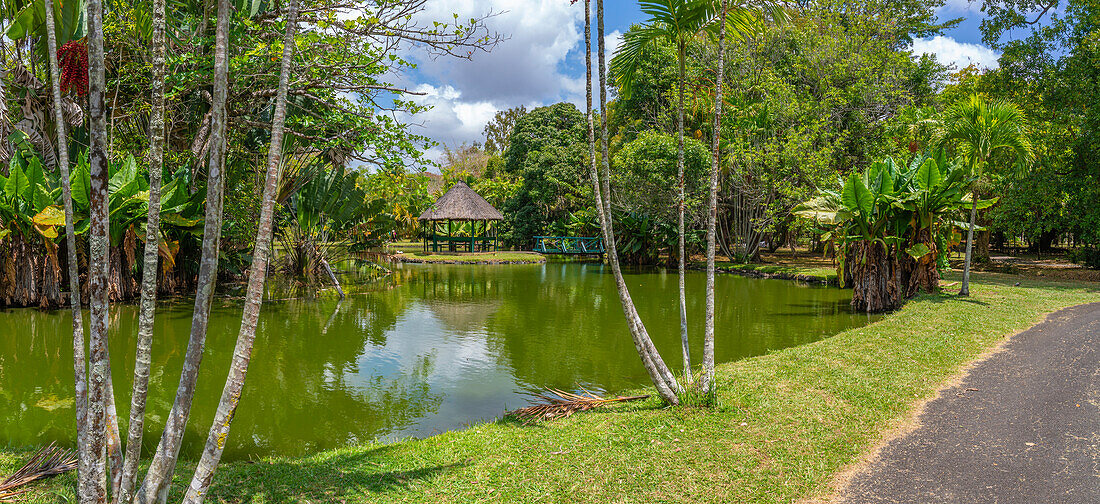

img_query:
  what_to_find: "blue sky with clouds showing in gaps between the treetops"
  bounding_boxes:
[402,0,998,158]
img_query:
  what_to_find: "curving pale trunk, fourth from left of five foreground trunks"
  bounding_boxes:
[136,0,232,504]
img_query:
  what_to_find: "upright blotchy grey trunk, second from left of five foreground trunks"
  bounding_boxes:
[83,0,110,503]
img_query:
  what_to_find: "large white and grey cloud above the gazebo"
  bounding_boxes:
[402,0,598,158]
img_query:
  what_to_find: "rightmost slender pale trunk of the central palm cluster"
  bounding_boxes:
[703,0,727,392]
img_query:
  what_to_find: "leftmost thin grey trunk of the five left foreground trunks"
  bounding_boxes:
[42,1,95,503]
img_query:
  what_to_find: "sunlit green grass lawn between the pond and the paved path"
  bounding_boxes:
[0,273,1100,503]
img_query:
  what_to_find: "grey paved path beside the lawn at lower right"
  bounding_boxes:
[839,303,1100,504]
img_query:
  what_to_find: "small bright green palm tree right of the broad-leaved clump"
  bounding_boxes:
[943,95,1032,296]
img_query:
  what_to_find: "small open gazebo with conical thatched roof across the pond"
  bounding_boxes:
[418,182,504,252]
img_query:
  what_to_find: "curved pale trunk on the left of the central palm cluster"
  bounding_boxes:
[586,0,681,404]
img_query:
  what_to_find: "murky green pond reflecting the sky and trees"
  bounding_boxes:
[0,262,872,459]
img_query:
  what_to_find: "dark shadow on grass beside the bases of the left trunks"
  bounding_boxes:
[208,446,470,503]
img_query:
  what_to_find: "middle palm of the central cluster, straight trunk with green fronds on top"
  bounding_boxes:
[601,0,714,376]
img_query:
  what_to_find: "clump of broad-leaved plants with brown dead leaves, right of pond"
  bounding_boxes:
[794,151,993,313]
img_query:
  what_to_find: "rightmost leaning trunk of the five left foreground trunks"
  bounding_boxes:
[184,0,299,504]
